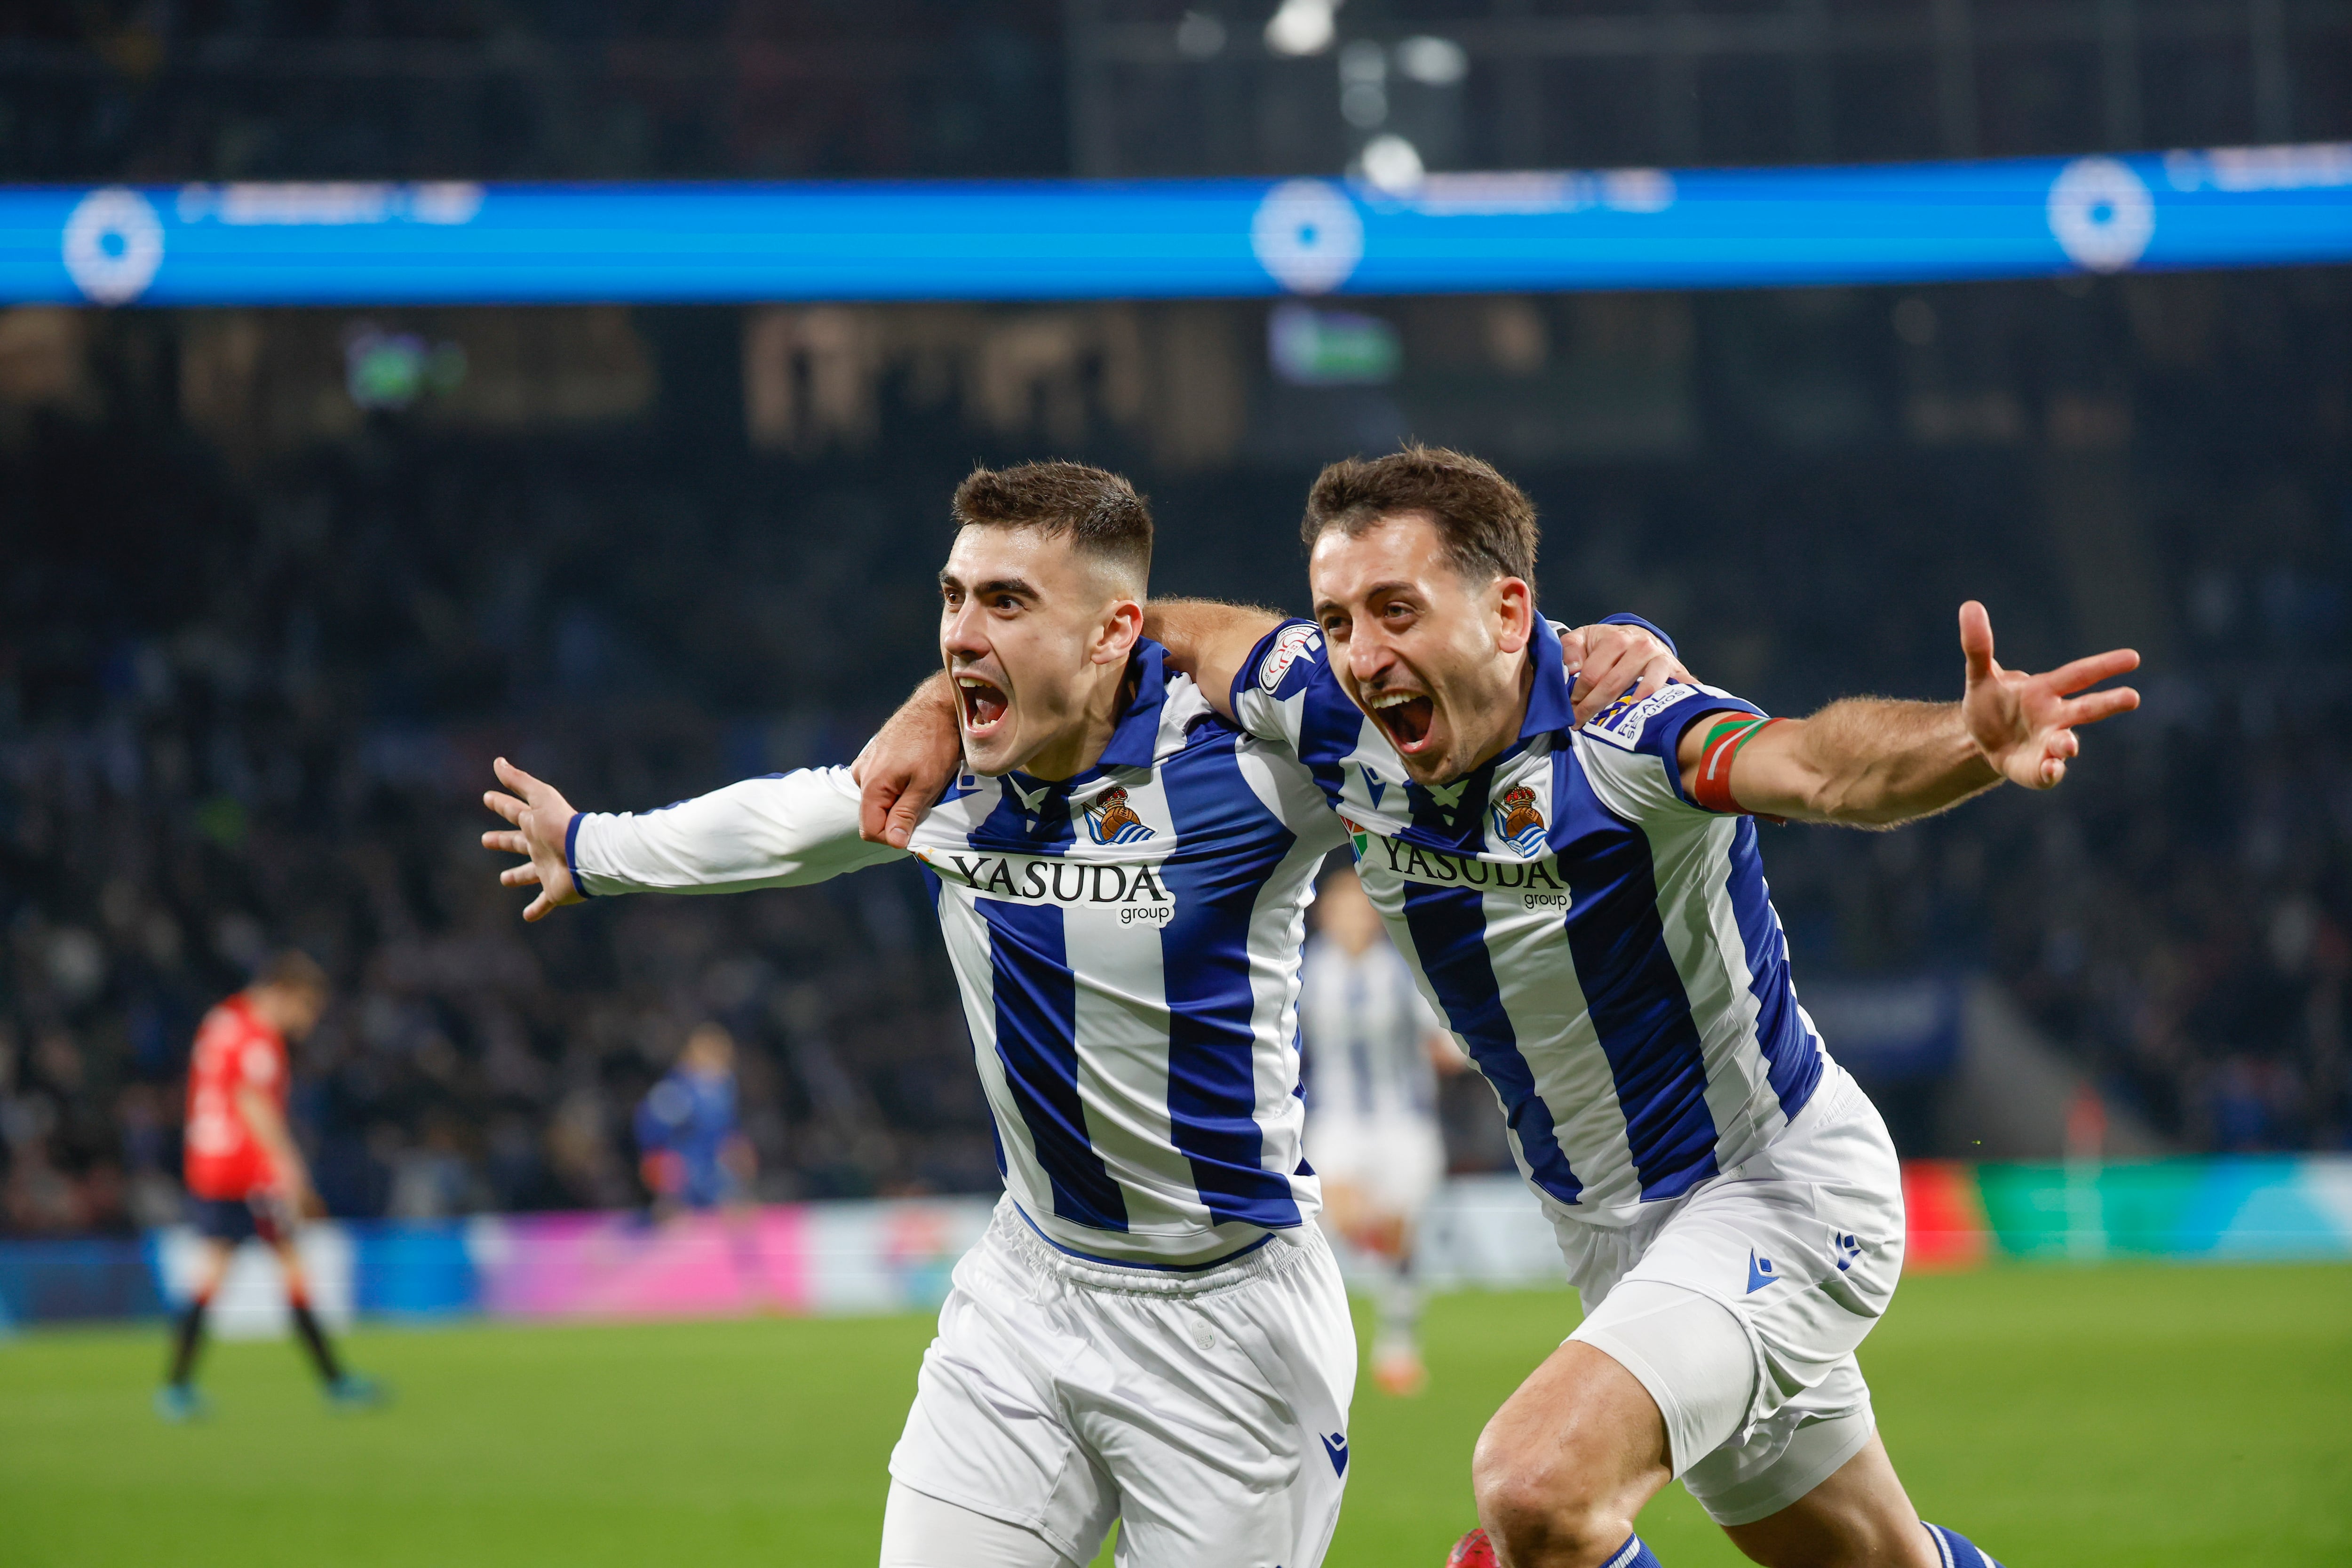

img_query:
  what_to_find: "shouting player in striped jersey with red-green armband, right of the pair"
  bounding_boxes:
[863,449,2138,1568]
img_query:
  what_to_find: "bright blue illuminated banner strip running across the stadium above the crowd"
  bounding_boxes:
[0,143,2352,306]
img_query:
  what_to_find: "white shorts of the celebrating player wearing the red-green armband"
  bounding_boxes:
[1552,1063,1903,1526]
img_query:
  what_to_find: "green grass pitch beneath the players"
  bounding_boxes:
[0,1267,2352,1568]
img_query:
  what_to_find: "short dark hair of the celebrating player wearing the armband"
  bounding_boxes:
[1298,444,1541,581]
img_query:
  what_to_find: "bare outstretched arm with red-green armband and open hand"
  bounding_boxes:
[1677,599,2140,828]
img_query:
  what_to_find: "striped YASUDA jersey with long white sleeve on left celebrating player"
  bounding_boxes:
[569,642,1343,1267]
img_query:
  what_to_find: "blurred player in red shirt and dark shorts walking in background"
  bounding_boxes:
[155,952,381,1420]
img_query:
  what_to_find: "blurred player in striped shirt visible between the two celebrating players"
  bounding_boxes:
[1298,870,1468,1394]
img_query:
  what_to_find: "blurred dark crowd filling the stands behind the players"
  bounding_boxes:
[0,261,2352,1229]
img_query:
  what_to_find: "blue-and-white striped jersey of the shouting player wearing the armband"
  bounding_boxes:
[1232,621,1828,1225]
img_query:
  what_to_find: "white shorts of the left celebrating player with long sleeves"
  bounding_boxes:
[889,1199,1355,1568]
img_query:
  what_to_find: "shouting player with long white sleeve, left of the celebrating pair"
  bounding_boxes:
[482,463,1675,1568]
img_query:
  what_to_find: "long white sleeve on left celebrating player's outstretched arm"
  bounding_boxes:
[564,769,906,898]
